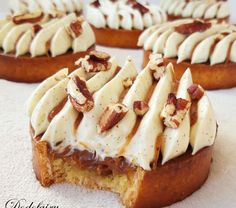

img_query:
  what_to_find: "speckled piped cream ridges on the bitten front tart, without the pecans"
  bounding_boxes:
[27,52,216,170]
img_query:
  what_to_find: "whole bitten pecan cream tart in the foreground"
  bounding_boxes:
[27,51,217,207]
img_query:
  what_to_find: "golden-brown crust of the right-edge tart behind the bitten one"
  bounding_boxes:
[143,51,236,90]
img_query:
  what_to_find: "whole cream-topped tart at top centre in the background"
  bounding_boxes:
[85,0,166,48]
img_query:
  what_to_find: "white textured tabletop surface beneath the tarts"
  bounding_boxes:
[0,0,236,208]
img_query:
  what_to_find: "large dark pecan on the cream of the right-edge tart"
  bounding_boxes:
[175,20,211,35]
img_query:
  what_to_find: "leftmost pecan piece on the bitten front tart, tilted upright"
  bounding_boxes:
[67,76,94,112]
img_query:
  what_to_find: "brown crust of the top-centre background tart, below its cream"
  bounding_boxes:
[91,25,143,49]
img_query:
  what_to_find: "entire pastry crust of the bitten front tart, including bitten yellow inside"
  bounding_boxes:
[32,134,213,208]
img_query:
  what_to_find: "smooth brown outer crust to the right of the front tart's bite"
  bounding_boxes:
[134,146,213,208]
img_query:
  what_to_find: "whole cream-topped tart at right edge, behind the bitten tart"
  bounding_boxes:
[138,19,236,89]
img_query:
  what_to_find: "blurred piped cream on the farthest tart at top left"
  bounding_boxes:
[9,0,83,15]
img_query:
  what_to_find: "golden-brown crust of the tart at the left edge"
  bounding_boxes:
[0,46,95,83]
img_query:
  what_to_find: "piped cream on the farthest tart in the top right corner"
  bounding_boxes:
[160,0,229,19]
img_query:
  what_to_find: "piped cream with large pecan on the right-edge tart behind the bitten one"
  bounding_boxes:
[138,19,236,65]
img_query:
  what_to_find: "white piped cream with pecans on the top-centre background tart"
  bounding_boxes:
[85,0,166,30]
